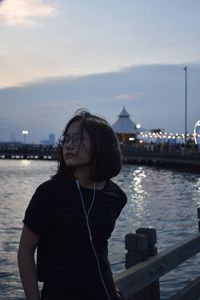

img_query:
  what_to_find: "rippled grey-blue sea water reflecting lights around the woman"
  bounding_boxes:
[0,159,200,300]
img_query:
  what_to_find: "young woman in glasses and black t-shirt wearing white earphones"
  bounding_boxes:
[18,111,127,300]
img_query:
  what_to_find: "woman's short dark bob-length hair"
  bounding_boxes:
[55,110,122,181]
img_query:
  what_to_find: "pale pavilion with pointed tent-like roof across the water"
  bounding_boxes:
[112,107,141,143]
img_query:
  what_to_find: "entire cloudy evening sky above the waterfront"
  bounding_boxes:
[0,0,200,143]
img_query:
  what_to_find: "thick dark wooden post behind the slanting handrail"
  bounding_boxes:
[125,228,160,300]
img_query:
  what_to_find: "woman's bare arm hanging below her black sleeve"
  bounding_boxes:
[18,225,40,300]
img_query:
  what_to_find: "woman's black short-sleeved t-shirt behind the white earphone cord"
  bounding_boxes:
[24,179,127,286]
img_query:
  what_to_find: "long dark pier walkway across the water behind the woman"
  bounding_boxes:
[0,143,200,172]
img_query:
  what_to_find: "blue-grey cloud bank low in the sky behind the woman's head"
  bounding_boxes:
[0,65,200,142]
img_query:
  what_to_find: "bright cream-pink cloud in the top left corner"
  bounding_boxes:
[0,0,55,26]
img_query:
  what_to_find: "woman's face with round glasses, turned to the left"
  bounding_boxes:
[63,121,92,168]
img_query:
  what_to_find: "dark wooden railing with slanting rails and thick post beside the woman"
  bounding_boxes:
[115,208,200,300]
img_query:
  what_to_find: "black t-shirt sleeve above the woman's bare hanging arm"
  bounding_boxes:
[23,185,52,235]
